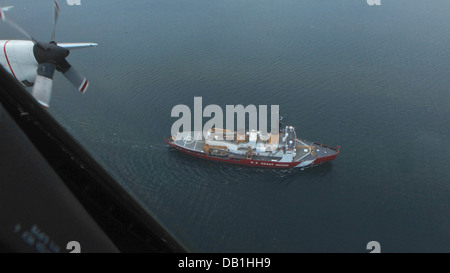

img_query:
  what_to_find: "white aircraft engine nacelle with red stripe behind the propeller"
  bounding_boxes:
[0,40,38,86]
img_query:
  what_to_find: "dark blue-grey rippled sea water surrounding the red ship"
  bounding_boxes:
[0,0,450,252]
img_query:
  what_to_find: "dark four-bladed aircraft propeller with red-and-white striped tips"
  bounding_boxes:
[0,1,89,108]
